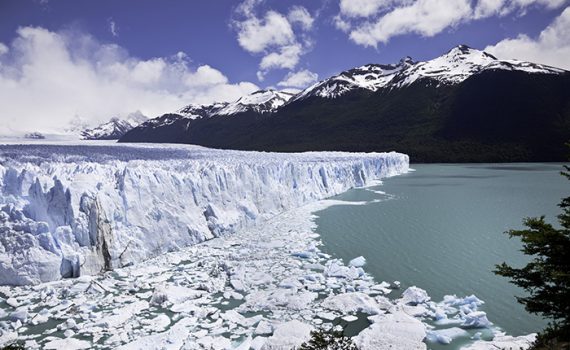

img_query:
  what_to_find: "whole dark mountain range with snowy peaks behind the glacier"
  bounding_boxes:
[119,45,570,162]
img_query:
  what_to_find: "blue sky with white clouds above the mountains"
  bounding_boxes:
[0,0,570,135]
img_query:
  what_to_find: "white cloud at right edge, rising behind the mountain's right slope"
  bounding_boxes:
[485,7,570,70]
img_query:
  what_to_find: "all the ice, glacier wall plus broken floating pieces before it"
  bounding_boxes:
[0,145,534,350]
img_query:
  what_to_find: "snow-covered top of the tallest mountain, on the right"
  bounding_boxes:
[293,45,565,100]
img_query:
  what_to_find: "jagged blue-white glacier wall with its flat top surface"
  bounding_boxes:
[0,144,409,285]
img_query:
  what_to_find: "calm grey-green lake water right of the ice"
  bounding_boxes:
[316,163,570,344]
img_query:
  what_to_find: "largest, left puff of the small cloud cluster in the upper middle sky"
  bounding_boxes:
[233,11,295,53]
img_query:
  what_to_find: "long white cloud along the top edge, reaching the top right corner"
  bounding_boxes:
[333,0,567,47]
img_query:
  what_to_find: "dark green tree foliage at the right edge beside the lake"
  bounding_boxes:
[495,166,570,344]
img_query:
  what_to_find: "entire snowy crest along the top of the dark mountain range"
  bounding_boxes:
[134,45,565,128]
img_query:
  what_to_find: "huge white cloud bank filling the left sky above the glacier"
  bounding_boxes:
[0,27,258,135]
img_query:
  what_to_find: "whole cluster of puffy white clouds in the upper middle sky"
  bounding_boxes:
[232,0,314,81]
